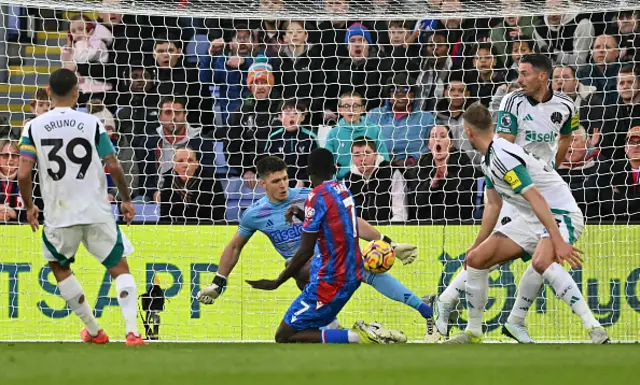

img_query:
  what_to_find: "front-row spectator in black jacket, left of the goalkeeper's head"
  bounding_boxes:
[160,147,226,224]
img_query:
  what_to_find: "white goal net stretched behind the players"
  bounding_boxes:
[0,0,640,342]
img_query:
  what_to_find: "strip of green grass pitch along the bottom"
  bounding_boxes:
[0,343,640,385]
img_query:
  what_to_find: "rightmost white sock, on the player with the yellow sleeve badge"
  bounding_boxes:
[542,262,600,329]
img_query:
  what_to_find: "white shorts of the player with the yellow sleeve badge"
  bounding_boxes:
[495,212,584,260]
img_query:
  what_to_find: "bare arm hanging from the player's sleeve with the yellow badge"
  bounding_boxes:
[522,186,583,268]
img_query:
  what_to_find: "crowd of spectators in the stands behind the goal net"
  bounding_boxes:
[0,0,640,223]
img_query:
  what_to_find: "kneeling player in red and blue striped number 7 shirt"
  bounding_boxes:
[247,148,407,343]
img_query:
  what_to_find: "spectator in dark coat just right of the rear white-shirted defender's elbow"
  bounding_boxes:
[558,127,600,217]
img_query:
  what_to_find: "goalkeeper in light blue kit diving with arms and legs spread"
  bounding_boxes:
[197,156,433,339]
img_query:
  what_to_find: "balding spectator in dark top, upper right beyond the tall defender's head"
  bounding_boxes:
[576,35,620,104]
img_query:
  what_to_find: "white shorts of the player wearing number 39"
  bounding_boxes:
[42,222,133,269]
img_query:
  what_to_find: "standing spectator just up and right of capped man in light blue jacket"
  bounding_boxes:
[418,31,453,112]
